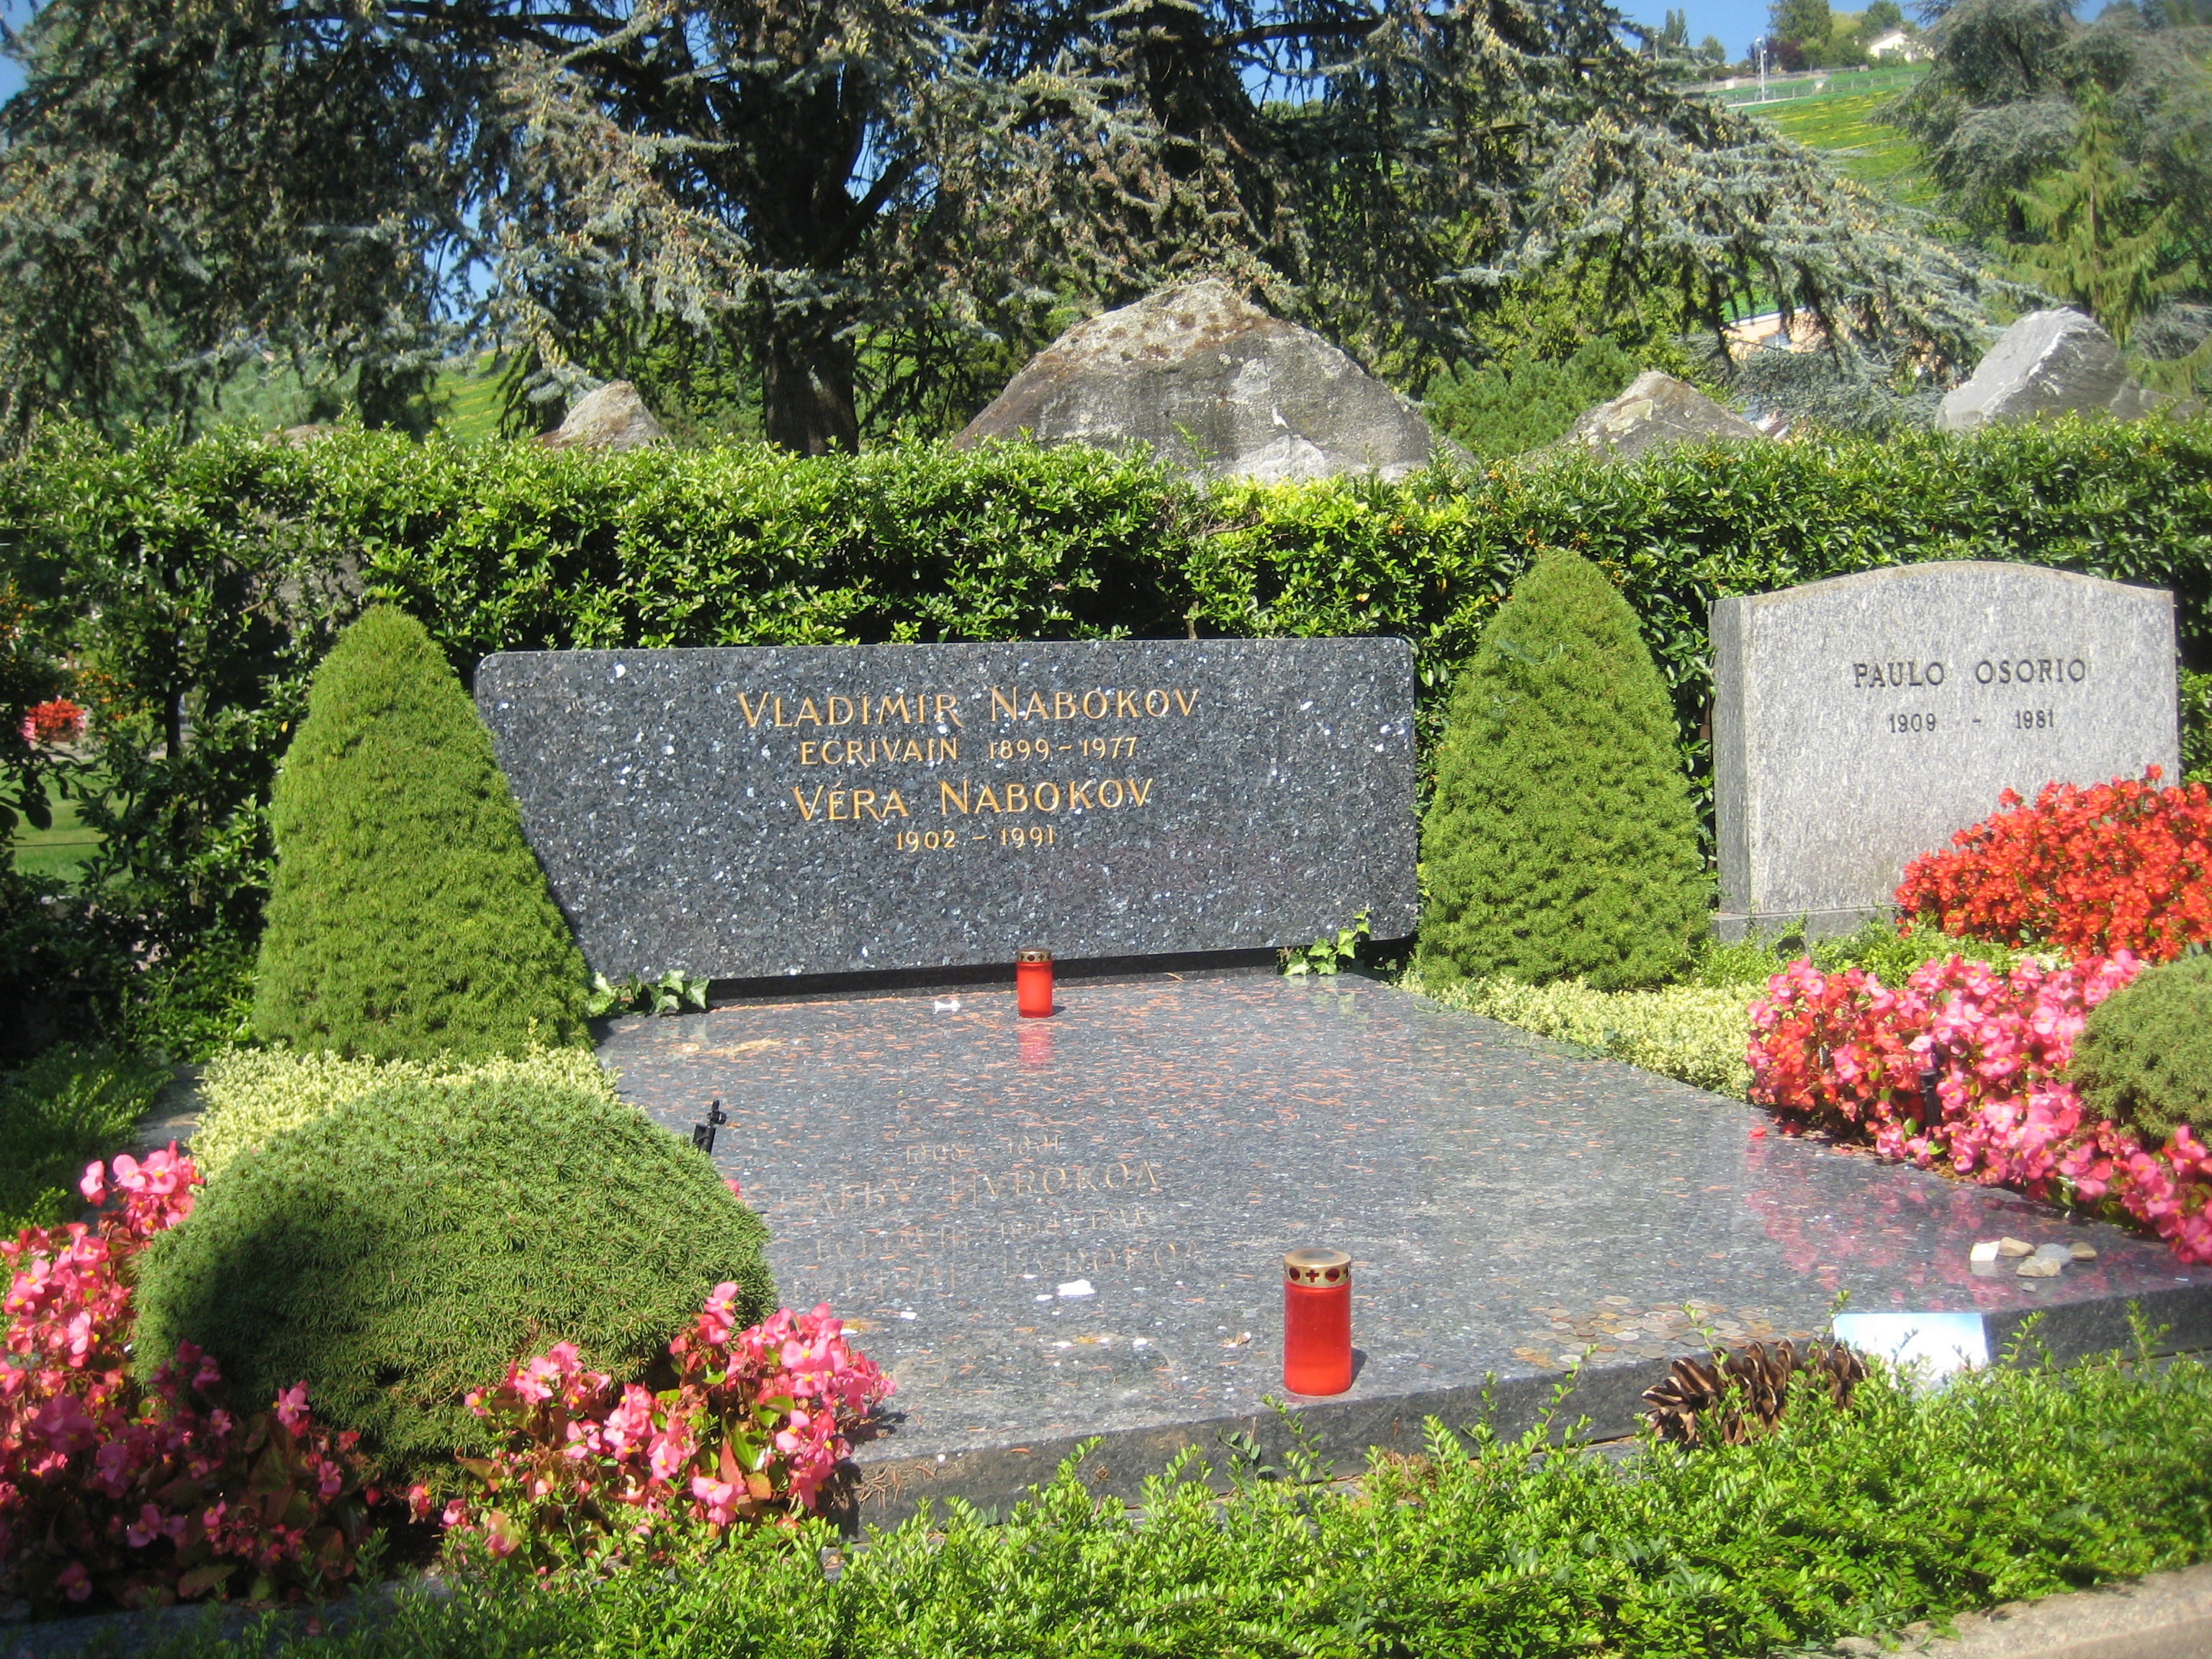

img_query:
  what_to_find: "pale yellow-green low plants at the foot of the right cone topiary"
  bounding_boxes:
[1398,974,1768,1100]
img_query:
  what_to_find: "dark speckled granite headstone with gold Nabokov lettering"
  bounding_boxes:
[475,639,1416,980]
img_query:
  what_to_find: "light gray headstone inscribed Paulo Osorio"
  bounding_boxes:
[1712,562,2181,938]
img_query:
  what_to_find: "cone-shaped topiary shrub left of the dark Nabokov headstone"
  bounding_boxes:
[254,606,584,1059]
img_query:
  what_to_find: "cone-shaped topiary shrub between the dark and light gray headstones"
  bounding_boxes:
[1420,553,1708,991]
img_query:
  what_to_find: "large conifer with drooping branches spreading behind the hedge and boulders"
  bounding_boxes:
[0,0,2008,454]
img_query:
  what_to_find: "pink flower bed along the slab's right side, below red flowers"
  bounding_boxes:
[1748,951,2212,1263]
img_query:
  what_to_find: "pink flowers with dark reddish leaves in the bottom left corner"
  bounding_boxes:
[0,1146,374,1610]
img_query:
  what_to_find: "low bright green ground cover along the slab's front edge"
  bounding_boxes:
[143,1358,2212,1659]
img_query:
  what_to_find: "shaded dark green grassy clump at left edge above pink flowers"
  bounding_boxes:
[0,1044,168,1238]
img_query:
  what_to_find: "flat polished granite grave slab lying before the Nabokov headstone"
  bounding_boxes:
[600,976,2212,1519]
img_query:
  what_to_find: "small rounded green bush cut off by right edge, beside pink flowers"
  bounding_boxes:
[2066,956,2212,1146]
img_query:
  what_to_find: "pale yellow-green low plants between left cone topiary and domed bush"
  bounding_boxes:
[192,1048,615,1181]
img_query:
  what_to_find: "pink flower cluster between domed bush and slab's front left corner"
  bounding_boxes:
[436,1285,891,1566]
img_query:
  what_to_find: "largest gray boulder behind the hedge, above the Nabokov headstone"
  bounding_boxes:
[953,281,1438,480]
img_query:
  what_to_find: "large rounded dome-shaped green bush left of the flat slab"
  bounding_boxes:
[137,1073,774,1480]
